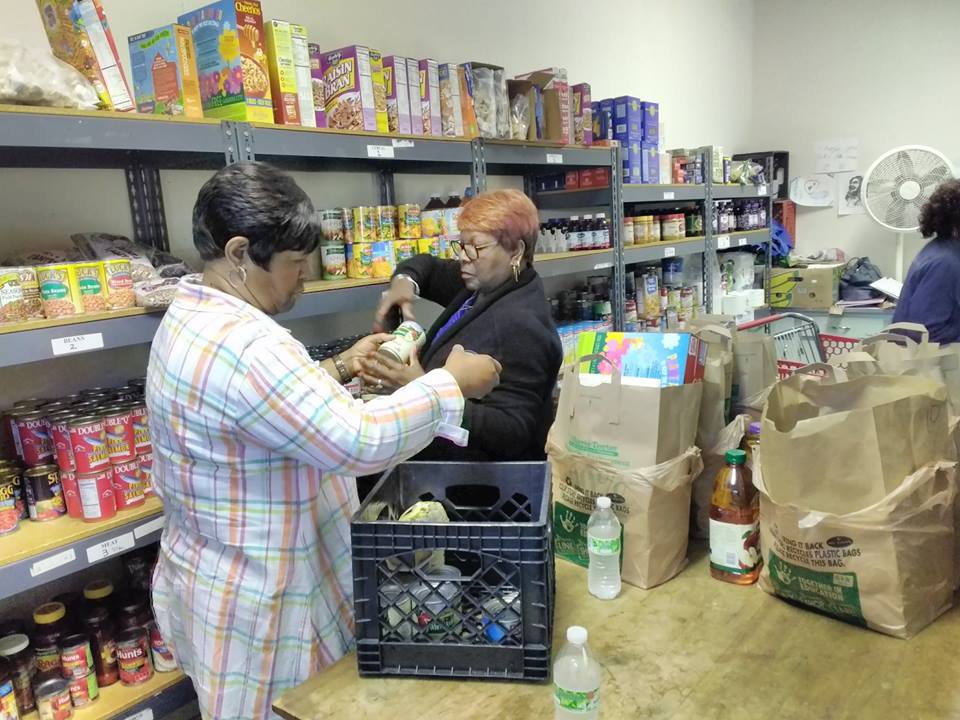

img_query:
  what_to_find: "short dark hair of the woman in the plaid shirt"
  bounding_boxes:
[193,162,320,269]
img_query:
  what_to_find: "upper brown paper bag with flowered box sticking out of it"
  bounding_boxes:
[548,356,703,469]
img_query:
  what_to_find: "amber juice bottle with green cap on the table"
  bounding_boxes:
[710,450,763,585]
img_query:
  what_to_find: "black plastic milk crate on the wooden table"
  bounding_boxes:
[351,462,555,682]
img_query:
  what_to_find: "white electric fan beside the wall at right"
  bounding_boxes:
[860,145,953,282]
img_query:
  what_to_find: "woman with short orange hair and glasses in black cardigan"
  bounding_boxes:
[362,190,563,461]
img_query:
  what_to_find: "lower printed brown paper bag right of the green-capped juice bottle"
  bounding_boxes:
[754,462,957,638]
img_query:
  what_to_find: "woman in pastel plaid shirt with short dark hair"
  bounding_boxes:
[147,163,500,720]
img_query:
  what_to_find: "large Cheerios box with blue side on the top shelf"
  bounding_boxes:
[178,0,273,123]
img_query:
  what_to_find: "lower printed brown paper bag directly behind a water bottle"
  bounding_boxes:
[548,446,703,588]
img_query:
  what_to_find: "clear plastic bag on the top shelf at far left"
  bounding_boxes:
[0,40,100,110]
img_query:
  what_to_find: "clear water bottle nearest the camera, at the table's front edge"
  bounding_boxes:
[553,625,600,720]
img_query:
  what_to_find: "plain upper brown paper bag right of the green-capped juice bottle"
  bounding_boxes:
[760,365,953,514]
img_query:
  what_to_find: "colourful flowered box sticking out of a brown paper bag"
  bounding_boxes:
[577,332,707,387]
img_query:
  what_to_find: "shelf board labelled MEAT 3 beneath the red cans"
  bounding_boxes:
[0,497,163,600]
